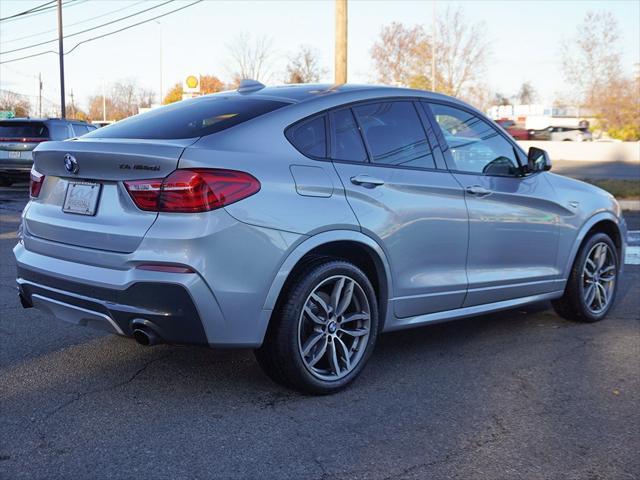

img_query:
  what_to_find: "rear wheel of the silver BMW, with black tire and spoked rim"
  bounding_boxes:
[255,258,378,395]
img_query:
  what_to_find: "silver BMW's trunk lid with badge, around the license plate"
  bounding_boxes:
[24,139,194,253]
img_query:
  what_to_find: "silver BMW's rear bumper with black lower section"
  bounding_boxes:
[14,244,225,345]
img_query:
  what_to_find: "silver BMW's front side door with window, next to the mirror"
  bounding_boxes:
[424,102,566,306]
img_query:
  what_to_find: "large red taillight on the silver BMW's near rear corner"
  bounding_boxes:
[124,169,260,213]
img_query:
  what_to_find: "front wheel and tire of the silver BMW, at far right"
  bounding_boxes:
[551,233,620,322]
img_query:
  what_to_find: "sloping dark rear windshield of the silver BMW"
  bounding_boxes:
[87,95,288,139]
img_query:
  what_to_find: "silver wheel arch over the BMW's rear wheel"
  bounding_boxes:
[264,230,392,330]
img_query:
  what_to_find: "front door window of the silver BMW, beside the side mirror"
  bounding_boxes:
[430,103,520,176]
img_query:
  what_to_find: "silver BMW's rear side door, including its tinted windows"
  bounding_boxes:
[329,100,468,318]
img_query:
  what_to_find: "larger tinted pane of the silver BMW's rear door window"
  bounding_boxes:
[353,102,435,168]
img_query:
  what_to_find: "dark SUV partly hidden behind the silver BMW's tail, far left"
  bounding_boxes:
[0,118,96,187]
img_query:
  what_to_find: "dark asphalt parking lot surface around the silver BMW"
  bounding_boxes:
[0,188,640,480]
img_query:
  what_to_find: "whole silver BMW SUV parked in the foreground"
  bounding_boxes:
[14,81,626,394]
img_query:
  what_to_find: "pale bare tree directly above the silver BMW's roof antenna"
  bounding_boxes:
[227,33,273,82]
